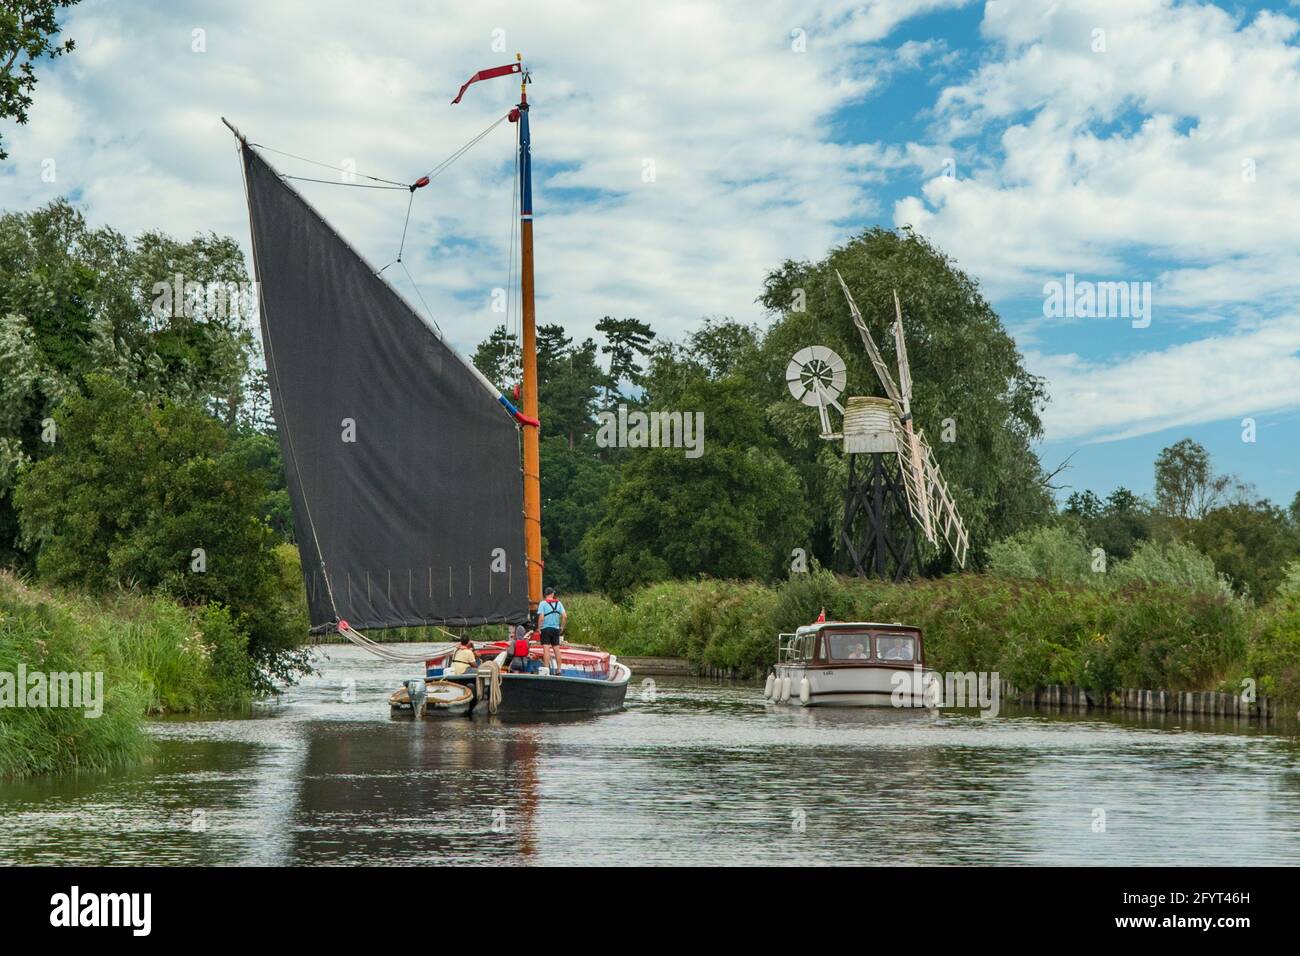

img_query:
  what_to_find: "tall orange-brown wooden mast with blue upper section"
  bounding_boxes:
[515,53,542,614]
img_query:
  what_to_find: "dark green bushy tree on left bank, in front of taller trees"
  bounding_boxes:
[14,375,300,675]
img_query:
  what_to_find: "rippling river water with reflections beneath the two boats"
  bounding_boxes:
[0,646,1300,865]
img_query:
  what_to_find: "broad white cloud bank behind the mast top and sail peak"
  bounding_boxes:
[0,0,961,356]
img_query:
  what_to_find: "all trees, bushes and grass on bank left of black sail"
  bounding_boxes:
[0,200,307,774]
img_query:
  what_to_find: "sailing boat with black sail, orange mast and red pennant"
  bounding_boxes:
[224,57,632,714]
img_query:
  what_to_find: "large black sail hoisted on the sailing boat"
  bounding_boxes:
[243,146,528,631]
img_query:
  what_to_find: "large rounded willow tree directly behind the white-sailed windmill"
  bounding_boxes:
[759,228,1052,571]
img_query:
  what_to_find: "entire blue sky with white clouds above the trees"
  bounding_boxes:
[0,0,1300,503]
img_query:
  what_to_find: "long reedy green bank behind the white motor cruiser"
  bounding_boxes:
[567,572,1300,702]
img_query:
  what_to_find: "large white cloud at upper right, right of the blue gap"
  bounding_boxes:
[894,0,1300,299]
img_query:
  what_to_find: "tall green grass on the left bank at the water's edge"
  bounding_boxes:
[0,572,251,777]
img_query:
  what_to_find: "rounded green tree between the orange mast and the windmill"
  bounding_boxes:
[584,377,807,594]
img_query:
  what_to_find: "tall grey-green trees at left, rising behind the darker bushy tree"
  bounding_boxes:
[0,200,259,563]
